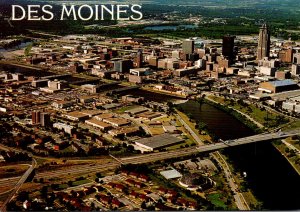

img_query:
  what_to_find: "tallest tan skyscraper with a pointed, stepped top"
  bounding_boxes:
[257,24,271,60]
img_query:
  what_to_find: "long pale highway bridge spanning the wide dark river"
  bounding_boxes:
[118,129,300,164]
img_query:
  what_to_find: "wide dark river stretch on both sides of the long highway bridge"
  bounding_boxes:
[180,101,300,210]
